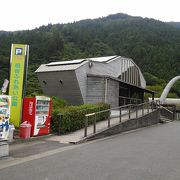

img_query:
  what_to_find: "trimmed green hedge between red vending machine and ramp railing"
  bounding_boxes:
[51,103,110,134]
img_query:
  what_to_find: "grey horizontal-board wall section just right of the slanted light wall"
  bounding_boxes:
[86,76,105,103]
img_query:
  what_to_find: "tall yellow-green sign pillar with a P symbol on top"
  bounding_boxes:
[9,44,29,127]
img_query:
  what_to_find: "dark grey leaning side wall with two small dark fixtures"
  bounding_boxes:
[38,71,83,105]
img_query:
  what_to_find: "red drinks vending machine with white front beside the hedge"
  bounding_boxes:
[22,96,52,136]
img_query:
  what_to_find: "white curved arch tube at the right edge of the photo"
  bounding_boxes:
[159,76,180,104]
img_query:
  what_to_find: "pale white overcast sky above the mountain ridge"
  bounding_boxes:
[0,0,180,31]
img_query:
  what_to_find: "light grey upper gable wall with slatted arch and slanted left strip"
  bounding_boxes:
[75,57,144,105]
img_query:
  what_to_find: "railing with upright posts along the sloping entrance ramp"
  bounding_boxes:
[84,102,157,137]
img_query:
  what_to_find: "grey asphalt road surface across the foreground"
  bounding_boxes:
[0,121,180,180]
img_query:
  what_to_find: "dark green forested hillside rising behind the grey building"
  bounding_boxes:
[0,14,180,95]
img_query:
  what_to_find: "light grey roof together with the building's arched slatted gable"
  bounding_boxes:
[36,55,146,88]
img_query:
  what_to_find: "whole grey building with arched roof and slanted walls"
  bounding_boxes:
[36,56,154,107]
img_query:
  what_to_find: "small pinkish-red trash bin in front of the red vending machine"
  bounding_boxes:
[19,121,31,139]
